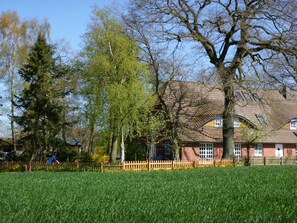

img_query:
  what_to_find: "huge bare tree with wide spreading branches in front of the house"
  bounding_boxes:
[130,0,297,157]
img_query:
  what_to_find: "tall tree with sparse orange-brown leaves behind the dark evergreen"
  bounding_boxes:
[0,11,49,150]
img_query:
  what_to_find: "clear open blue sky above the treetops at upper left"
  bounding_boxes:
[0,0,119,51]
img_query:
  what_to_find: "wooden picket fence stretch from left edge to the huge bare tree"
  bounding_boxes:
[0,159,234,172]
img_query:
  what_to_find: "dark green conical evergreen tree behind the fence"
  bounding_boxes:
[16,33,66,160]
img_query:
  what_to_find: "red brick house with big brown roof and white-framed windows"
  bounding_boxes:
[156,81,297,161]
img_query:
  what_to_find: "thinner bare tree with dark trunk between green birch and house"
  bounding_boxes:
[124,11,190,160]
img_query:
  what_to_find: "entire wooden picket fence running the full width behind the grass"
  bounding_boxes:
[0,157,297,172]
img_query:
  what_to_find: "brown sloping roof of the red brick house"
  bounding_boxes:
[163,81,297,143]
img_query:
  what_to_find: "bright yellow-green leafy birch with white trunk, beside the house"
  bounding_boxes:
[83,7,153,162]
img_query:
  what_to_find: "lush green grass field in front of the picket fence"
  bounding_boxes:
[0,166,297,223]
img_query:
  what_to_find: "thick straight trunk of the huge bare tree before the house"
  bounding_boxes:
[222,75,235,158]
